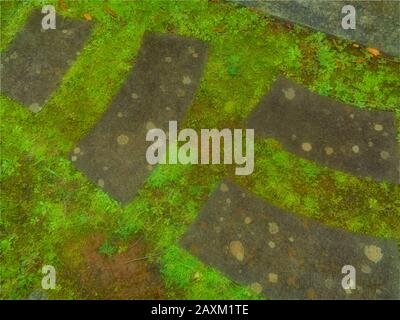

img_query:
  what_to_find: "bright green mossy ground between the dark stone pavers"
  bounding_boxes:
[0,0,400,299]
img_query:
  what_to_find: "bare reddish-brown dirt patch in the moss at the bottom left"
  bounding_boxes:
[64,235,165,300]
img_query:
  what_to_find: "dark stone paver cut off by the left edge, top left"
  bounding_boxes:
[1,10,92,112]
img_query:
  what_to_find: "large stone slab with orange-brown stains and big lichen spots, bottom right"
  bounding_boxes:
[182,181,400,299]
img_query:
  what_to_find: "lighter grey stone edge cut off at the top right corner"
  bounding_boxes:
[229,0,400,56]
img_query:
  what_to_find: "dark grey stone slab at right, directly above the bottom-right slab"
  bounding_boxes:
[247,77,400,183]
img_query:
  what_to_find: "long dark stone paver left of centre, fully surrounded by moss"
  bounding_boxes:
[69,33,207,203]
